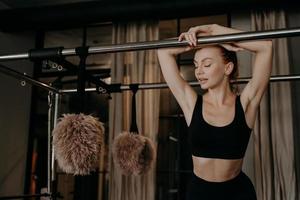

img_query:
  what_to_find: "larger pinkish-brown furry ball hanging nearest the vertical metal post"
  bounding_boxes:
[52,114,104,175]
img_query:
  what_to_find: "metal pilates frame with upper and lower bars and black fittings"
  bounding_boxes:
[0,28,300,199]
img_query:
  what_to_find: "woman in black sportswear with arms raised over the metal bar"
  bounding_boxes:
[158,24,272,200]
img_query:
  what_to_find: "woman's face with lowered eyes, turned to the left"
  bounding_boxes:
[194,46,226,90]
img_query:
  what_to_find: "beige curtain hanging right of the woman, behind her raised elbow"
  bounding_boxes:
[251,11,296,200]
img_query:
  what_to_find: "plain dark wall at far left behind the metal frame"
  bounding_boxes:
[0,32,34,196]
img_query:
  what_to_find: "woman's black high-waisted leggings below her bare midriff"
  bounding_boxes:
[186,172,257,200]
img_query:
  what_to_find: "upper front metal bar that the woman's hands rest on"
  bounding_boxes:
[0,28,300,61]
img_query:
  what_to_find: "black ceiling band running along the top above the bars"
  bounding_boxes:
[0,0,300,31]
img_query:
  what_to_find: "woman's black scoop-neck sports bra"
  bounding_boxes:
[188,95,252,159]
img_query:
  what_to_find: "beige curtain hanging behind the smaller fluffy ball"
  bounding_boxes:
[109,22,160,200]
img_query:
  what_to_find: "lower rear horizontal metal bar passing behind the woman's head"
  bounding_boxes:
[59,75,300,93]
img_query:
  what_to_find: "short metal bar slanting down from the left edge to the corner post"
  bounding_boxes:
[0,64,59,93]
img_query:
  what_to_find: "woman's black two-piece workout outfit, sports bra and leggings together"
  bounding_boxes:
[187,96,256,200]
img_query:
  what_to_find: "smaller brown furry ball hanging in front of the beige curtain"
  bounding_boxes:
[113,132,155,175]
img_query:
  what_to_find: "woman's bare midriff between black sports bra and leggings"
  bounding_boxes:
[193,156,243,182]
